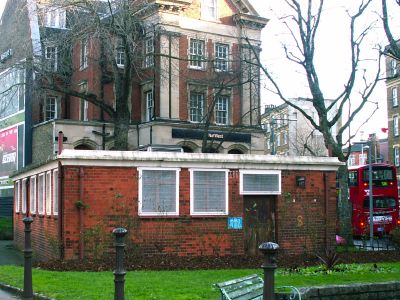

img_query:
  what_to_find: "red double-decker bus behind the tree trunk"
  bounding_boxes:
[349,164,400,236]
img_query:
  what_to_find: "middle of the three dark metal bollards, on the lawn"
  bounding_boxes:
[113,228,128,300]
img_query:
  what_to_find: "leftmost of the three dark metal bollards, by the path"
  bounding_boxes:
[22,217,33,300]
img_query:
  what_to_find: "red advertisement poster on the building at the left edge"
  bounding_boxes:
[0,126,18,178]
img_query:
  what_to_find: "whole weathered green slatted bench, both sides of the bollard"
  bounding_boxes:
[215,274,301,300]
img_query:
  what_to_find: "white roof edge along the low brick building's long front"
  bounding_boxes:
[57,149,343,170]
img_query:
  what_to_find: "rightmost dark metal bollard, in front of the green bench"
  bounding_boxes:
[258,242,279,300]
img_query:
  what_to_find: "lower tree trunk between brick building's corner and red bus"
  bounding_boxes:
[337,164,353,245]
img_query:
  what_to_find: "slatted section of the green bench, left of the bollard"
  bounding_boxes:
[215,274,264,300]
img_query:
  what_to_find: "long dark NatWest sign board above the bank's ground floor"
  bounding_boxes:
[172,128,251,144]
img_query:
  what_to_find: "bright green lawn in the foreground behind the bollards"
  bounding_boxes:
[0,263,400,300]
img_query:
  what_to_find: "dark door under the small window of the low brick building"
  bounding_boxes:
[244,195,276,256]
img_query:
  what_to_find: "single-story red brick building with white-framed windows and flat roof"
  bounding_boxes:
[13,150,341,260]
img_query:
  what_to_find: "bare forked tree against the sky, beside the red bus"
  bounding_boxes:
[247,0,380,241]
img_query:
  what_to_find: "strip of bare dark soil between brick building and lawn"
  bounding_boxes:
[34,251,400,271]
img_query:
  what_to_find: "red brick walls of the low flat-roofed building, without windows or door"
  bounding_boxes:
[14,166,336,259]
